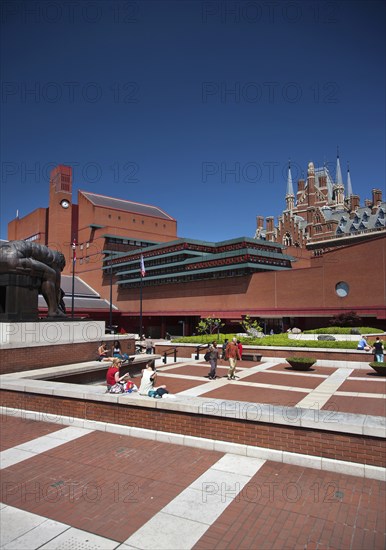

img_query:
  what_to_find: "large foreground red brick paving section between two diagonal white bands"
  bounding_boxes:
[2,428,222,542]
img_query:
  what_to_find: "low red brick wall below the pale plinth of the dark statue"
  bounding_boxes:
[0,339,135,374]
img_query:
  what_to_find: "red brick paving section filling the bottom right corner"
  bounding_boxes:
[194,462,386,550]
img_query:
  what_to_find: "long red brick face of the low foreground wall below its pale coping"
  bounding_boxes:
[0,390,386,467]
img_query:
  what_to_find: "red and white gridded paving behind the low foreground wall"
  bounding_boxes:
[153,359,386,416]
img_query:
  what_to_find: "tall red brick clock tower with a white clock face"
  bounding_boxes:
[47,164,74,273]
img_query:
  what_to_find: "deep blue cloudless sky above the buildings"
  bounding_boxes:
[0,0,386,241]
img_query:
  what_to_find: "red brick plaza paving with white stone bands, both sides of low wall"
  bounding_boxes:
[1,358,386,550]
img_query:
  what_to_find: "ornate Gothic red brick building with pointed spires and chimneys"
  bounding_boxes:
[255,156,386,251]
